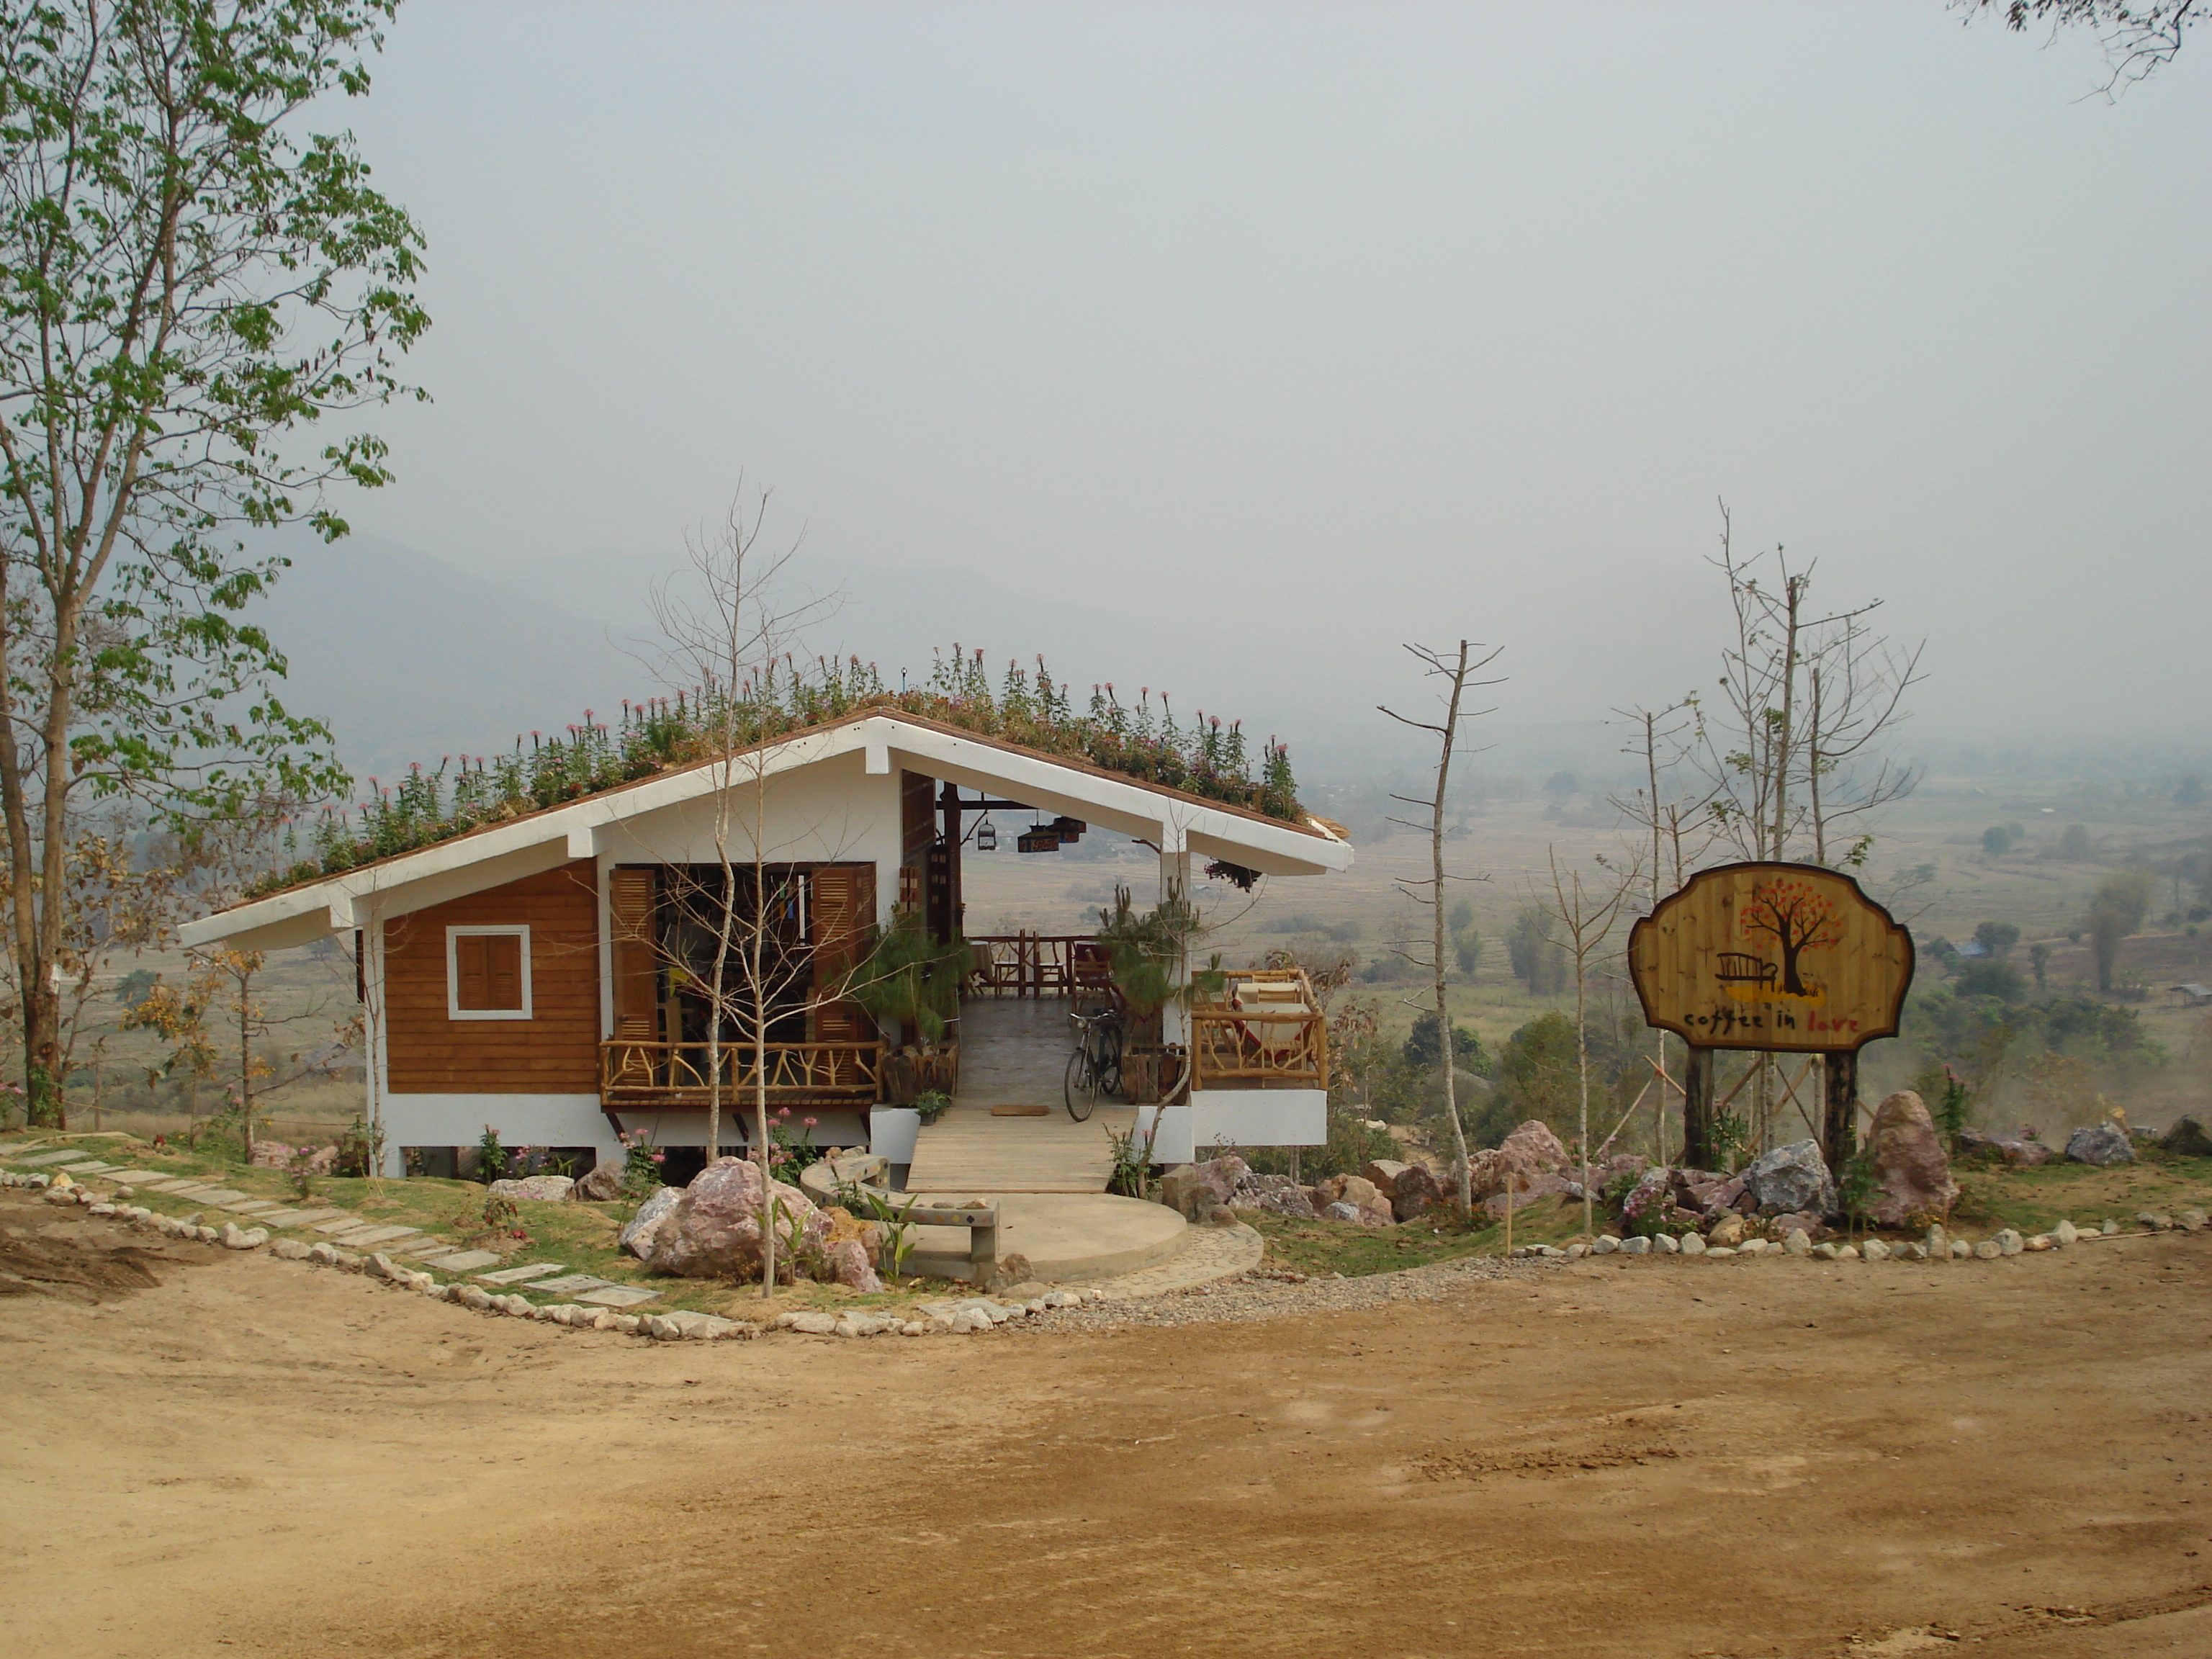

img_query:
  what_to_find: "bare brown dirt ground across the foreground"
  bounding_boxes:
[0,1195,2212,1659]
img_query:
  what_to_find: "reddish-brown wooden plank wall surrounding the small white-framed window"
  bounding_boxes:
[385,858,600,1095]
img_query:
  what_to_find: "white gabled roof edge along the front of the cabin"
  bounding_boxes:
[179,712,1352,951]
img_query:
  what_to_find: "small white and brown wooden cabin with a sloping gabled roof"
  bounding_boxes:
[184,710,1352,1174]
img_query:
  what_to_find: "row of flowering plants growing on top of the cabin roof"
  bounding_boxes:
[248,646,1298,898]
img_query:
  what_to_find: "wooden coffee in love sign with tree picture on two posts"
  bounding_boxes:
[1628,863,1913,1174]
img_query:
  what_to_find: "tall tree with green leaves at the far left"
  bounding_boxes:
[0,0,429,1124]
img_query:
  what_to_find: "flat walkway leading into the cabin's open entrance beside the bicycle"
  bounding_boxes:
[907,997,1137,1199]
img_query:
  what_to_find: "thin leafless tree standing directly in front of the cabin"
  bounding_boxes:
[652,493,845,1296]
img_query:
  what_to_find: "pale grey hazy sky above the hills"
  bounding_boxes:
[302,0,2212,774]
